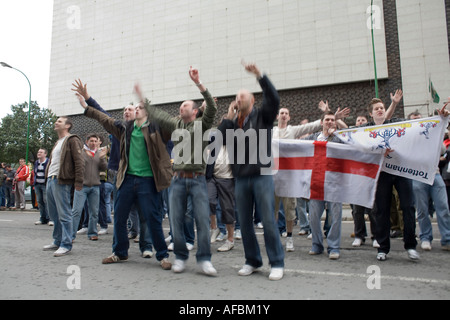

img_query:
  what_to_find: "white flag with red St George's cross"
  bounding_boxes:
[272,139,383,208]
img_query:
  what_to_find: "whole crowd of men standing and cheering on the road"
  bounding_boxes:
[5,63,450,280]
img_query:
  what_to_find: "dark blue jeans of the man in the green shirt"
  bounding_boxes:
[112,174,169,261]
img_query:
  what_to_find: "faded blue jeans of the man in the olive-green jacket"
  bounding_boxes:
[169,176,211,262]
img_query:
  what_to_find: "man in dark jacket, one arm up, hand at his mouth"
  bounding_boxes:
[219,63,284,280]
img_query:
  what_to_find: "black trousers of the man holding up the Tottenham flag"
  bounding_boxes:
[375,171,417,253]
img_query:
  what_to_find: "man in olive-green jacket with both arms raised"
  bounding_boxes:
[136,67,217,276]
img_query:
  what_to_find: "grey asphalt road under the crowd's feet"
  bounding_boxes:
[0,211,450,301]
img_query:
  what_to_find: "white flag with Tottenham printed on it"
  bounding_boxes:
[335,116,448,185]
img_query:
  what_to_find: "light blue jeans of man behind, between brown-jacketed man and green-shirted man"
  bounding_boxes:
[72,186,100,239]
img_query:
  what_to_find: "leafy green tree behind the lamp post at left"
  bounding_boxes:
[0,101,58,163]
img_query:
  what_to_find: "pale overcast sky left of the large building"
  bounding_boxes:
[0,0,53,119]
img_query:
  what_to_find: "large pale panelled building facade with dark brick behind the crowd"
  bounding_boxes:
[49,0,450,139]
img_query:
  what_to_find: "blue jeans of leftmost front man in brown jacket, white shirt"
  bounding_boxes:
[47,177,73,250]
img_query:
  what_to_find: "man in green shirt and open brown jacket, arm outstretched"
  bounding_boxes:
[74,81,172,270]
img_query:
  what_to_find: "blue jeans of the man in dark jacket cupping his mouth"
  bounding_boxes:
[235,176,284,268]
